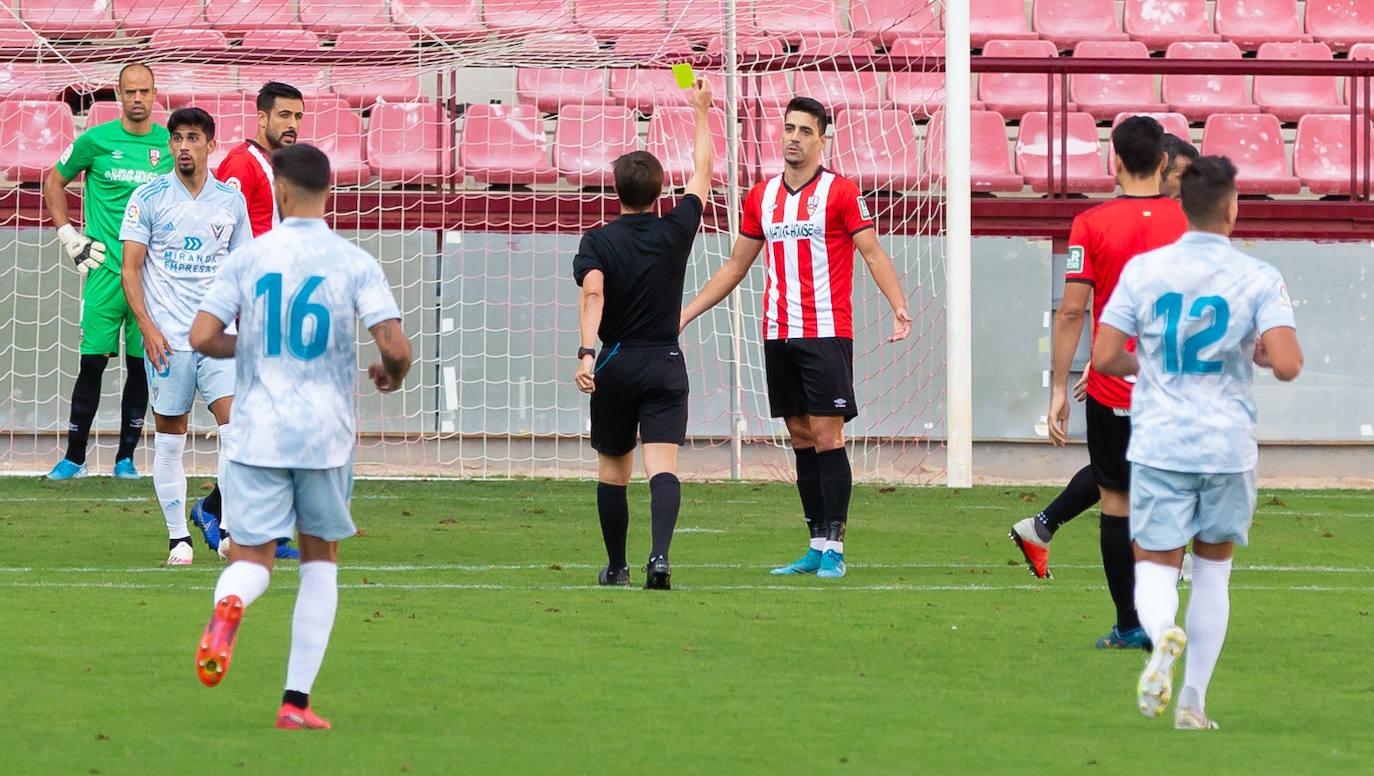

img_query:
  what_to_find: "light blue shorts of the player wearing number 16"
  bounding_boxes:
[220,460,357,547]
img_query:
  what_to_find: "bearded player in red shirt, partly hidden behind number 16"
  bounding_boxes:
[214,81,305,238]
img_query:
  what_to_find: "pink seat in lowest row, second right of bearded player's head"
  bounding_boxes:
[367,103,463,185]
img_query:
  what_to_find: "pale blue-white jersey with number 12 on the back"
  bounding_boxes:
[1101,232,1297,474]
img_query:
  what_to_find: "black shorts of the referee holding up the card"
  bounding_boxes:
[592,343,687,456]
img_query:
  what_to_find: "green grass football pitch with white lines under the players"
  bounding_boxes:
[0,478,1374,775]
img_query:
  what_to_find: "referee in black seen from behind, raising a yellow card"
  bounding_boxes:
[573,80,712,591]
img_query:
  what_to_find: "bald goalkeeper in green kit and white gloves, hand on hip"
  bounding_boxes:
[43,65,172,479]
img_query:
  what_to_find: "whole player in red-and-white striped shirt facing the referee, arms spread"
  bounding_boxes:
[682,98,911,578]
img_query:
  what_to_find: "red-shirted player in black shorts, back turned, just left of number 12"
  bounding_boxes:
[1050,115,1187,650]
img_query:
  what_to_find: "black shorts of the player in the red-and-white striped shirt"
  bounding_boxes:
[764,336,859,420]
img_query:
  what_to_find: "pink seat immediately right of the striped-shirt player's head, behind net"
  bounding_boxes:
[830,109,923,191]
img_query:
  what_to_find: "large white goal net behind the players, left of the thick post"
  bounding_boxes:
[0,0,945,482]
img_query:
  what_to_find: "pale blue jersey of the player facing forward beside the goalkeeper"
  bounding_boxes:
[120,172,253,353]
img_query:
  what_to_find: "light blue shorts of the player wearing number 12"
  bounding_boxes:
[1131,463,1256,551]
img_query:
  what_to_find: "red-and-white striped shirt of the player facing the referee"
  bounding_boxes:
[739,168,872,339]
